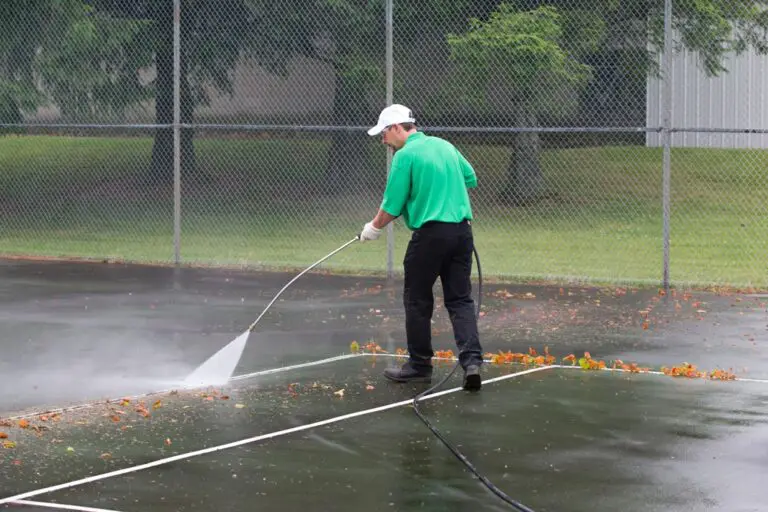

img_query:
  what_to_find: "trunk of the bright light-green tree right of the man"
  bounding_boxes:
[500,107,544,206]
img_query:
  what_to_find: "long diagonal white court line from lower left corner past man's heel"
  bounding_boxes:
[0,366,551,505]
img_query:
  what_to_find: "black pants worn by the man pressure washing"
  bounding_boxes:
[403,221,482,368]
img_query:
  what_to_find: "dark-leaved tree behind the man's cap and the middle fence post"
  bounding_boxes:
[242,0,497,193]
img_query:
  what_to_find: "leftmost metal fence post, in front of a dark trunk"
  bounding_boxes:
[173,0,181,265]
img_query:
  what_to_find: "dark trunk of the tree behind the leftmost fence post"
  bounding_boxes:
[148,2,195,185]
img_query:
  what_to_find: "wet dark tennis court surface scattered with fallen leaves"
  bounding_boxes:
[0,261,768,512]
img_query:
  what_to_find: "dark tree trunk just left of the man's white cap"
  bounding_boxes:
[324,70,370,194]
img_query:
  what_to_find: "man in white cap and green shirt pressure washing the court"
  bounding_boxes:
[360,104,482,391]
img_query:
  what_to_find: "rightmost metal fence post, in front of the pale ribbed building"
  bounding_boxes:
[661,0,672,291]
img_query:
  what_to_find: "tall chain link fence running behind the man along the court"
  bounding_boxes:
[0,0,768,287]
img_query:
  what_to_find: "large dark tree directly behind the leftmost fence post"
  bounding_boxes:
[91,0,260,183]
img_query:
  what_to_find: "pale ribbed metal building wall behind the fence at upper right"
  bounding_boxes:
[646,47,768,148]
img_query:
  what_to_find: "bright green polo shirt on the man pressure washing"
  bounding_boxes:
[381,132,477,230]
